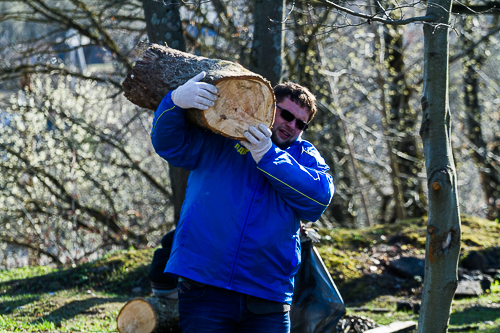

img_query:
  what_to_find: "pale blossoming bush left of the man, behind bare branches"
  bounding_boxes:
[0,76,168,263]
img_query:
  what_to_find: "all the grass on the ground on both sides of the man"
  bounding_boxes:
[0,217,500,333]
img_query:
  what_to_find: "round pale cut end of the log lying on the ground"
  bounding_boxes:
[116,298,156,333]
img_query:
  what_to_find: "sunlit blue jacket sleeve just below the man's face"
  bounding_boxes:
[257,143,335,221]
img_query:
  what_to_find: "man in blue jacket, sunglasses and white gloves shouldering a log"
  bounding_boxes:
[151,72,334,333]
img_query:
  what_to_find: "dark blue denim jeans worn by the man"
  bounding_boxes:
[178,280,290,333]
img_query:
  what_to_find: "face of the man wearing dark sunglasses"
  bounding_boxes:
[271,97,309,149]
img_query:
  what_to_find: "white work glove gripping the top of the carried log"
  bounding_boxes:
[172,72,217,110]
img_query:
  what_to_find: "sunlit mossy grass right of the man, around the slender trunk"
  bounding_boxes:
[318,216,500,333]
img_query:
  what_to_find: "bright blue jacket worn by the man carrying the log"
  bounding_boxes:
[151,93,334,304]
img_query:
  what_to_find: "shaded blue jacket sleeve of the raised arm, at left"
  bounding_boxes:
[151,92,204,170]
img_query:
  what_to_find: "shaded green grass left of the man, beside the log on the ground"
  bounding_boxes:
[0,250,153,332]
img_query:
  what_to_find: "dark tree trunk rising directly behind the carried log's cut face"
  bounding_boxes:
[250,0,286,86]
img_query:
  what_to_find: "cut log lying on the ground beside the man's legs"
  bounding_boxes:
[116,297,181,333]
